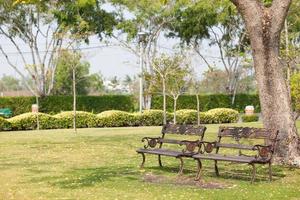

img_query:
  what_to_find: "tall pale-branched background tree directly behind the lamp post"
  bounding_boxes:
[110,0,179,109]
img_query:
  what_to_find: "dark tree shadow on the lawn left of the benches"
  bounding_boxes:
[31,167,140,189]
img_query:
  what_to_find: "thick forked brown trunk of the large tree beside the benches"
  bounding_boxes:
[231,0,300,166]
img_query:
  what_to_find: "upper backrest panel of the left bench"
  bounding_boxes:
[161,124,206,137]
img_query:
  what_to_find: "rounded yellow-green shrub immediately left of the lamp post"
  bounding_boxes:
[97,110,138,127]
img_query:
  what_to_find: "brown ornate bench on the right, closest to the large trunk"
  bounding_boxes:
[193,127,278,183]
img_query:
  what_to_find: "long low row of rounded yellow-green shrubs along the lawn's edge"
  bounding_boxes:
[0,108,239,131]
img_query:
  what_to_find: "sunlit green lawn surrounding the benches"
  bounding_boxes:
[0,123,300,200]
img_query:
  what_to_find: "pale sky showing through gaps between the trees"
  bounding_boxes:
[0,4,220,79]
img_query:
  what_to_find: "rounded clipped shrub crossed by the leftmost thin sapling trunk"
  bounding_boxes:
[8,112,60,130]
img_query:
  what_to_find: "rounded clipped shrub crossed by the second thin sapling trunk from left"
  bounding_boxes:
[54,111,98,128]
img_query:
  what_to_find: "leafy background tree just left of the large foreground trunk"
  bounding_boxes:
[169,1,248,104]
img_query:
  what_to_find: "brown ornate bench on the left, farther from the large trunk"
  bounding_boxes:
[136,124,206,174]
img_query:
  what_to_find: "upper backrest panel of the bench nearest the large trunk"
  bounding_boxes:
[218,127,278,141]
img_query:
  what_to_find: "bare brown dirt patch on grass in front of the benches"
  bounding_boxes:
[143,174,234,189]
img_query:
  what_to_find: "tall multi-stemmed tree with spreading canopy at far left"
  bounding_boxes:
[0,0,114,96]
